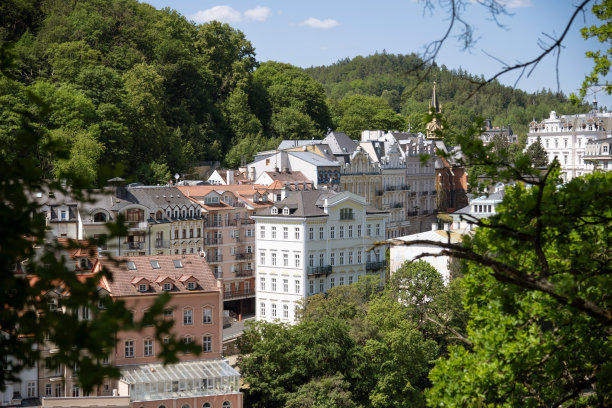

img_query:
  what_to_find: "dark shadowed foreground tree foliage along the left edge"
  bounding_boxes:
[0,47,199,392]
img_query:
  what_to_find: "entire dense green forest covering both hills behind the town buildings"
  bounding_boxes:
[0,0,592,183]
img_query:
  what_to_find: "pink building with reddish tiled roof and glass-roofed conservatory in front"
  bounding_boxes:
[101,255,242,408]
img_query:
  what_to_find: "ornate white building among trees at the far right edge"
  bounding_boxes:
[527,107,612,181]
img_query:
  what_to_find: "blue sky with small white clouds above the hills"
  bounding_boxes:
[145,0,612,114]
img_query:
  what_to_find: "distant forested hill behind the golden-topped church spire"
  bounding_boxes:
[306,52,585,139]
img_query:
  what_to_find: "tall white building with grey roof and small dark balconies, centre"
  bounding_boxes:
[252,190,387,323]
